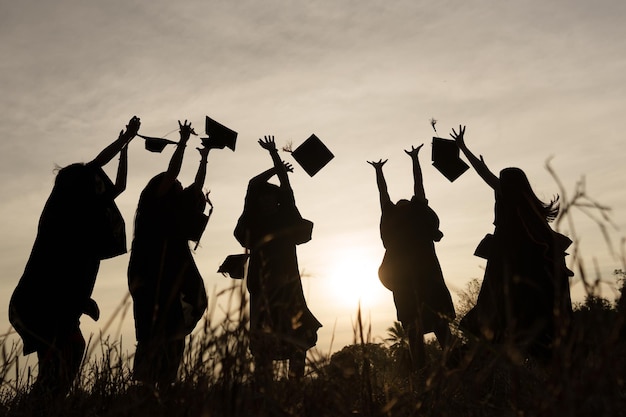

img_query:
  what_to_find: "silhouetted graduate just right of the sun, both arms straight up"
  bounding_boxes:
[368,145,455,369]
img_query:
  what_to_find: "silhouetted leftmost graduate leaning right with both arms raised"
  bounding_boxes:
[9,117,140,397]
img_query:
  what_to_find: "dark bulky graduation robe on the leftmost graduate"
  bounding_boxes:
[9,164,126,354]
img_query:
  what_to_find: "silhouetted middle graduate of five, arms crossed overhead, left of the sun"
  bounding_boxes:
[235,136,321,384]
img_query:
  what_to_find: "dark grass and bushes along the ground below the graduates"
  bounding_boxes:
[0,271,626,417]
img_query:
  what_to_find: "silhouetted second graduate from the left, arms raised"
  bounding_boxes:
[128,121,209,388]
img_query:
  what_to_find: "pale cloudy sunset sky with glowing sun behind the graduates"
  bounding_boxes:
[0,0,626,358]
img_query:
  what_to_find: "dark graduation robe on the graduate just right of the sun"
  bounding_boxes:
[378,197,455,334]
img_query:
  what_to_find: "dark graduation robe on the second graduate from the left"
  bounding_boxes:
[128,174,208,342]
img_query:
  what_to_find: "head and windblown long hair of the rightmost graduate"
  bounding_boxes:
[500,167,559,221]
